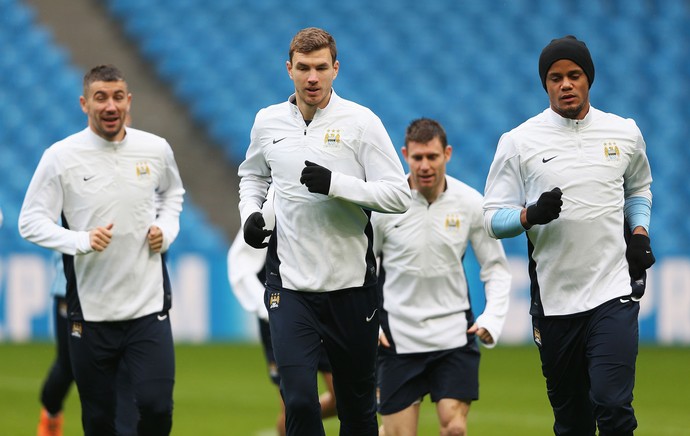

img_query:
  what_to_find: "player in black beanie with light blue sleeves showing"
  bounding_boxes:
[484,35,654,436]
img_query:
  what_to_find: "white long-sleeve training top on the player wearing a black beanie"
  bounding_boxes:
[484,107,652,316]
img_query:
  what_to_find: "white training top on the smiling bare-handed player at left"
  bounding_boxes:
[19,127,184,321]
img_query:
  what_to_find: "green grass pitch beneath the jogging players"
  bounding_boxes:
[0,343,690,436]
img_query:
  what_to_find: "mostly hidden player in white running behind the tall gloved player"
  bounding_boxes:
[228,187,336,436]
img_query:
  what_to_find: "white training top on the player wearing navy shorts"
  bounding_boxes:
[372,176,511,354]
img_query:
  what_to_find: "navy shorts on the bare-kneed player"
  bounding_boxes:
[377,341,480,415]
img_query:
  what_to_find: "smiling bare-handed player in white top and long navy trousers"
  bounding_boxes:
[19,65,184,436]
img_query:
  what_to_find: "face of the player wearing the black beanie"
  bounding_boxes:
[546,59,589,120]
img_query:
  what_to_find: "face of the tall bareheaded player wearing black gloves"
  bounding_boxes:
[286,48,340,115]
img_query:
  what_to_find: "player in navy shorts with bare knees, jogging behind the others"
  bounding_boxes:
[372,118,511,436]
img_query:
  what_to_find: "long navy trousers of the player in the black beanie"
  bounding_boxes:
[532,297,640,436]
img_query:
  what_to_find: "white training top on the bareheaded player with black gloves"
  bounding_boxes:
[238,91,410,292]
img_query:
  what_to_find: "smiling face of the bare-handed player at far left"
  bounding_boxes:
[79,80,132,141]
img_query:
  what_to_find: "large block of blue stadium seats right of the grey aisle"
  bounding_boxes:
[101,0,690,255]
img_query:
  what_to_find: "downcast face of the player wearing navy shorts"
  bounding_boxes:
[402,137,453,202]
